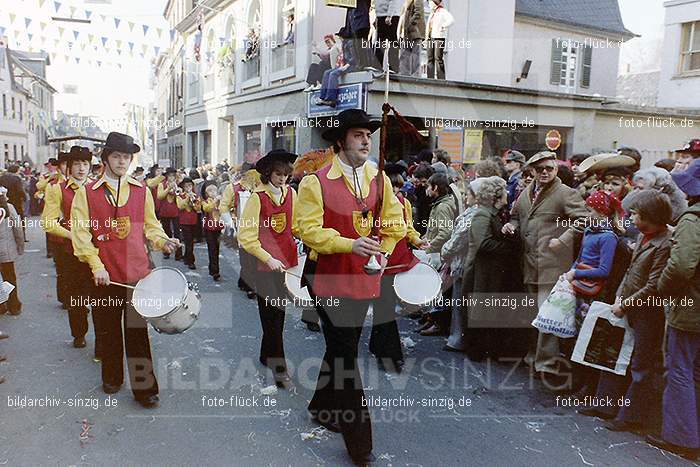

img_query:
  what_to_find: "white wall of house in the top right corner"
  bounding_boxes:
[658,0,700,108]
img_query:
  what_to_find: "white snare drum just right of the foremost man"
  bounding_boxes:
[394,263,442,309]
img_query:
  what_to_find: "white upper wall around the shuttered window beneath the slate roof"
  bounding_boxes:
[509,17,620,96]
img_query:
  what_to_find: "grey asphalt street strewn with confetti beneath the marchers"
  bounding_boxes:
[0,218,690,466]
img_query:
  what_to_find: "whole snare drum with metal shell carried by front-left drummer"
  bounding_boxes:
[131,267,201,334]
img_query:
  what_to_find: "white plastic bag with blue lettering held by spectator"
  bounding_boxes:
[532,275,576,338]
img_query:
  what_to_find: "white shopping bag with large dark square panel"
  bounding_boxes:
[571,302,634,375]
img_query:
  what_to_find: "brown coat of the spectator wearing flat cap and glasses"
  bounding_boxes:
[510,178,588,284]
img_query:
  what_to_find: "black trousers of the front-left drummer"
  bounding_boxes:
[92,285,158,399]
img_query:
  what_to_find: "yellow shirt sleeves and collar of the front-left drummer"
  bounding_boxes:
[70,177,168,273]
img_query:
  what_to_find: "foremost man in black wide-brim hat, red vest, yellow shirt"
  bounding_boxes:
[298,109,406,463]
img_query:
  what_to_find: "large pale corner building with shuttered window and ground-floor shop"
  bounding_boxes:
[150,0,700,166]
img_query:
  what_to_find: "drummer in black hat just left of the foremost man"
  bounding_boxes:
[238,149,299,387]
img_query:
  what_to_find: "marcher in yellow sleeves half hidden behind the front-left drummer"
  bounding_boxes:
[42,146,100,360]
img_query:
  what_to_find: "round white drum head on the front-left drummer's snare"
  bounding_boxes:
[131,267,187,319]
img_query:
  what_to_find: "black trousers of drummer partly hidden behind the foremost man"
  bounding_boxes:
[369,274,403,361]
